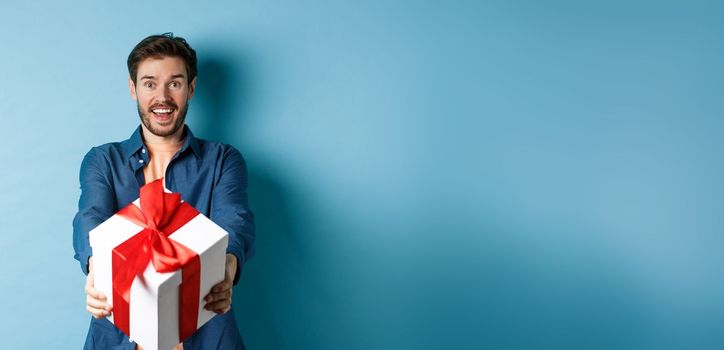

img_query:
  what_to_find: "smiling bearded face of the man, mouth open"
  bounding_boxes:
[128,57,196,137]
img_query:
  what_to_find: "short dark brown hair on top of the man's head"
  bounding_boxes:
[127,33,196,84]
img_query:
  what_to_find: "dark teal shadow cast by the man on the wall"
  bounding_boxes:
[191,50,350,349]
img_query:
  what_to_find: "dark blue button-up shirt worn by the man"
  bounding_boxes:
[73,126,254,350]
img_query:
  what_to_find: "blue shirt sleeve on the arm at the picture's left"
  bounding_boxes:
[73,147,115,274]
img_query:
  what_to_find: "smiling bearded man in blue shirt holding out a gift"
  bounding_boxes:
[73,33,254,350]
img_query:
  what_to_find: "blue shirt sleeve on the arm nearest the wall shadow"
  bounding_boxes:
[211,146,255,284]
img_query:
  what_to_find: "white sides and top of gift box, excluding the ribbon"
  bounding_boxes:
[89,199,229,350]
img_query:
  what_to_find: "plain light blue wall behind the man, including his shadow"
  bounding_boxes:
[0,0,724,349]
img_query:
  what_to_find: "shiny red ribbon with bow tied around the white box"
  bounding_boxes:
[112,178,201,341]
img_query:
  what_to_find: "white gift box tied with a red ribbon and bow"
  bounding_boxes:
[89,179,229,350]
